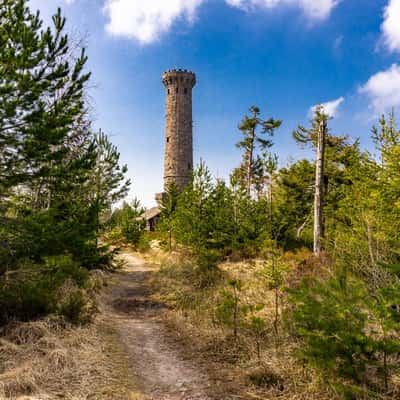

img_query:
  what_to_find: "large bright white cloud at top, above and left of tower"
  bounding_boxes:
[104,0,204,44]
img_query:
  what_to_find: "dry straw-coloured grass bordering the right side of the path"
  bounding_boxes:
[153,255,338,400]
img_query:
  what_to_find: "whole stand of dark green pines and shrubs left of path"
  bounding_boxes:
[0,0,129,324]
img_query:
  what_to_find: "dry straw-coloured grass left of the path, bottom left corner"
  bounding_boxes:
[0,319,140,400]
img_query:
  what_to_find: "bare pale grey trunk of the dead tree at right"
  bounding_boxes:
[314,118,327,255]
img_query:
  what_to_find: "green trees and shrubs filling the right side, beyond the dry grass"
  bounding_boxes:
[148,107,400,399]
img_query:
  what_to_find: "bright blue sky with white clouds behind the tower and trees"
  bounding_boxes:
[30,0,400,206]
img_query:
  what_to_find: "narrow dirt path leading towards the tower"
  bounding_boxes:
[104,254,228,400]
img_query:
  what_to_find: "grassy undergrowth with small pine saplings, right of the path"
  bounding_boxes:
[154,251,400,400]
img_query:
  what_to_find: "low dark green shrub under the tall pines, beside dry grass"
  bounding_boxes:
[0,256,93,324]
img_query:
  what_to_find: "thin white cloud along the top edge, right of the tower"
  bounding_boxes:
[225,0,342,20]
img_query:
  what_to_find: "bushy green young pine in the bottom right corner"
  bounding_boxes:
[287,271,400,398]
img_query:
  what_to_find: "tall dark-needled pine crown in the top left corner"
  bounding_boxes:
[0,0,90,198]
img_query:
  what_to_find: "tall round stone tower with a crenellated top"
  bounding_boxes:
[162,69,196,189]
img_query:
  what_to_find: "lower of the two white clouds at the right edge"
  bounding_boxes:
[359,64,400,114]
